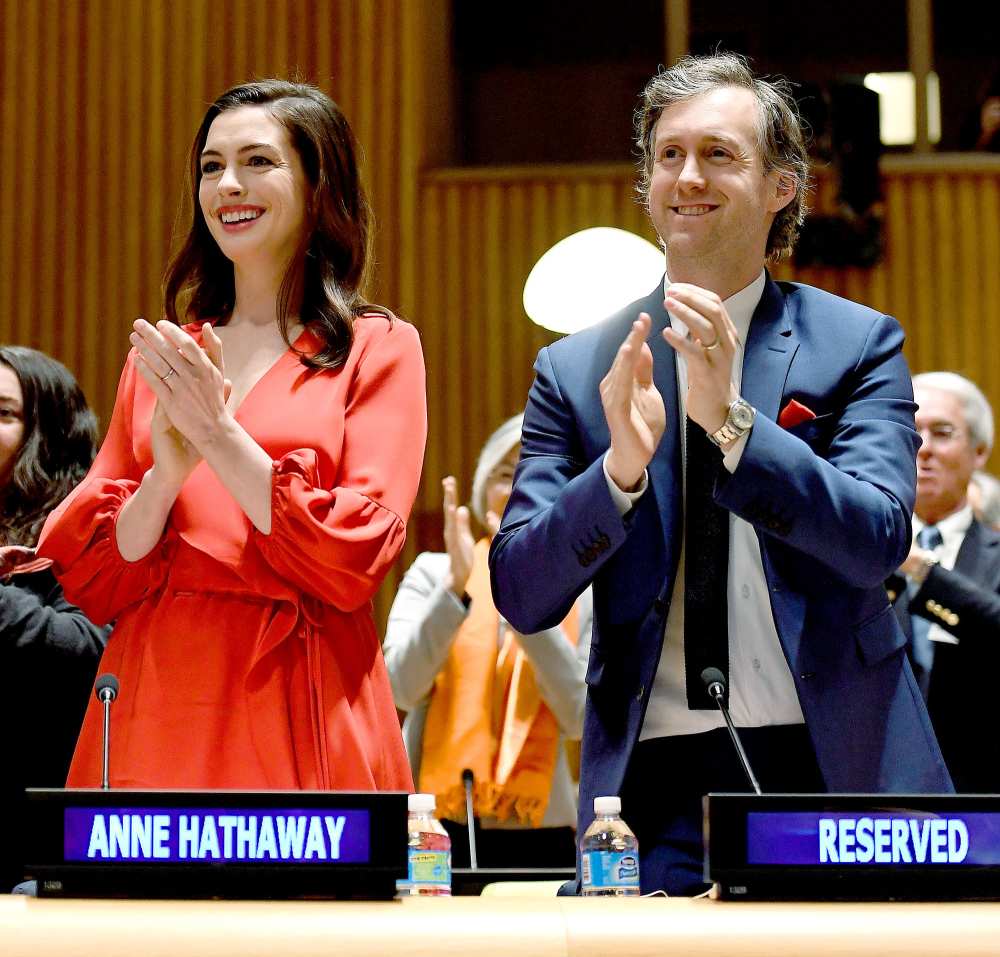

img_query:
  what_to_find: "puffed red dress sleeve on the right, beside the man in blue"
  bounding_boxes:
[252,320,427,612]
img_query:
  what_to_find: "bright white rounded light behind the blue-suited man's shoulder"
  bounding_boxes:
[524,226,664,332]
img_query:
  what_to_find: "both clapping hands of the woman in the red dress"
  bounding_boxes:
[129,319,232,486]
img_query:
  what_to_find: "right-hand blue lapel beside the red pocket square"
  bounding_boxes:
[740,277,799,422]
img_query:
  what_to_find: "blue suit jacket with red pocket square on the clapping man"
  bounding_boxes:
[490,279,951,833]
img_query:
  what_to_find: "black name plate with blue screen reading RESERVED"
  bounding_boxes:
[704,794,1000,900]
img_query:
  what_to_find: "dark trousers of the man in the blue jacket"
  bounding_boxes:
[621,724,826,896]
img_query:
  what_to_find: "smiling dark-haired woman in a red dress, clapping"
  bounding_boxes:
[42,80,426,790]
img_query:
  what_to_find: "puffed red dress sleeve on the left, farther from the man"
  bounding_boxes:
[38,353,174,624]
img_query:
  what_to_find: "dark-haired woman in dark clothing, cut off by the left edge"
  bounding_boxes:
[0,346,110,889]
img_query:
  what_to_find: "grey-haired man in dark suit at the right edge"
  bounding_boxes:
[887,372,1000,793]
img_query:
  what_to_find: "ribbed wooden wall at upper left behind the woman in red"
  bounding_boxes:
[0,0,420,628]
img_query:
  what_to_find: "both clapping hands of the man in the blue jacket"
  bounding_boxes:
[600,283,739,491]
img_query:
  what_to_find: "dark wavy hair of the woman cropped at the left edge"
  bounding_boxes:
[0,346,97,546]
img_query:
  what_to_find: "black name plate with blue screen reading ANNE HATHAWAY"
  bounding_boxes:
[25,789,407,899]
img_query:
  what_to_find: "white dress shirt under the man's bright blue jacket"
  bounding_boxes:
[604,270,804,741]
